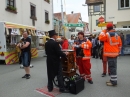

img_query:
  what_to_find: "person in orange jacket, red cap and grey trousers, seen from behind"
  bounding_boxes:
[99,23,122,86]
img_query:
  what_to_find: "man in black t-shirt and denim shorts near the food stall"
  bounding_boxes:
[17,31,31,79]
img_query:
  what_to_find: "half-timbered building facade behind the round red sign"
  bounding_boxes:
[85,0,105,33]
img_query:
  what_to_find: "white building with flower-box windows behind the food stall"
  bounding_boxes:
[0,0,53,31]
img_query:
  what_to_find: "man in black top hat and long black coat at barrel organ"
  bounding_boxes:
[45,30,68,93]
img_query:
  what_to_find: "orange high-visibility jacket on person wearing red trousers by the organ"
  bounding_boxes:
[81,39,92,60]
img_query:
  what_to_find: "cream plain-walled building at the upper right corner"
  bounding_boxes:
[105,0,130,28]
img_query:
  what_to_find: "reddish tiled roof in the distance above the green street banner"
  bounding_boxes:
[67,13,81,23]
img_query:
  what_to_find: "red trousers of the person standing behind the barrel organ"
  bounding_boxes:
[76,58,92,81]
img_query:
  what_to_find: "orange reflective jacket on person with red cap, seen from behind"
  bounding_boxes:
[99,30,122,57]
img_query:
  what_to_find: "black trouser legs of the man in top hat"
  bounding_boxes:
[48,64,65,91]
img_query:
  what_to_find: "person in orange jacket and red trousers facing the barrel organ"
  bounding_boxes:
[74,32,93,84]
